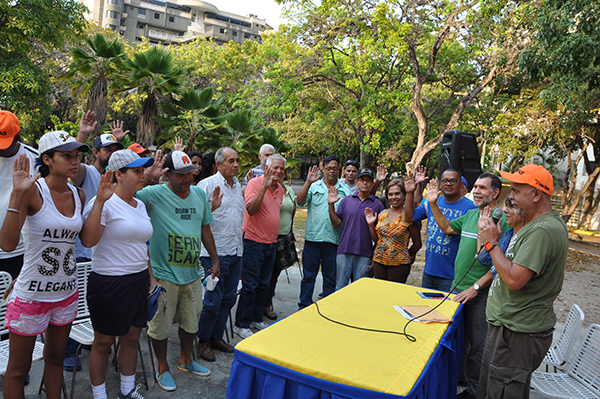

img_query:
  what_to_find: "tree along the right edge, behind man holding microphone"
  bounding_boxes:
[521,0,600,225]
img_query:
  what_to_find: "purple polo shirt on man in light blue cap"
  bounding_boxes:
[335,194,383,258]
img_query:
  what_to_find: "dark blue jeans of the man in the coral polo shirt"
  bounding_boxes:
[235,238,277,328]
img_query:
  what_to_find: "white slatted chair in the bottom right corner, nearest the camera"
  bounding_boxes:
[531,324,600,399]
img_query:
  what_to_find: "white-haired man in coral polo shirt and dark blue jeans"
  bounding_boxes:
[234,154,286,338]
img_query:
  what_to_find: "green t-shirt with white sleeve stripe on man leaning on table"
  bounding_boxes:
[450,209,510,294]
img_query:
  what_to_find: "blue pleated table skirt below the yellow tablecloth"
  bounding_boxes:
[227,306,463,399]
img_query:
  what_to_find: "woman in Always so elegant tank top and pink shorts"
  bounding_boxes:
[0,131,89,399]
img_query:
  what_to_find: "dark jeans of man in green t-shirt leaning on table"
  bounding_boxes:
[463,293,488,396]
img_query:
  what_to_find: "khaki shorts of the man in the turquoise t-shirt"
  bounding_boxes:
[148,279,202,341]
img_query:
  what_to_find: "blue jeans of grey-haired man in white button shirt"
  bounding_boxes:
[196,256,242,341]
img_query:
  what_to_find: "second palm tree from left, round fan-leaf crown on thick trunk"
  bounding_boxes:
[118,46,183,147]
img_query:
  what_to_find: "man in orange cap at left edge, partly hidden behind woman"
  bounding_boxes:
[0,111,38,279]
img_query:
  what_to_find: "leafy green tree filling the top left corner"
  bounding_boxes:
[0,0,85,134]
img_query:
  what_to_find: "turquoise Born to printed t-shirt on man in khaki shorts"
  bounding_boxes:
[136,184,213,285]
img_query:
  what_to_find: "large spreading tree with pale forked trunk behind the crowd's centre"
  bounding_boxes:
[274,0,519,170]
